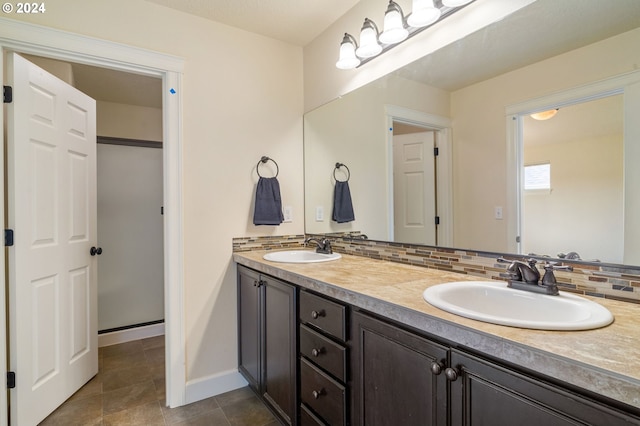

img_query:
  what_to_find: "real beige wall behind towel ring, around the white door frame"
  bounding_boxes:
[8,0,304,392]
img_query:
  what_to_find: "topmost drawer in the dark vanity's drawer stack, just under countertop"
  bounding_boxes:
[300,292,347,340]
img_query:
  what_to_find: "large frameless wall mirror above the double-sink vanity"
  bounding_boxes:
[304,0,640,266]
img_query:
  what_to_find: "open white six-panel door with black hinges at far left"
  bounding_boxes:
[7,54,98,425]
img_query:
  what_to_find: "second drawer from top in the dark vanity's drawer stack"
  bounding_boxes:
[300,325,347,382]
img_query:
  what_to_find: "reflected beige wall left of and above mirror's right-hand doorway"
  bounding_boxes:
[451,29,640,251]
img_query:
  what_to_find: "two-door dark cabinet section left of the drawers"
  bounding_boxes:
[238,265,298,425]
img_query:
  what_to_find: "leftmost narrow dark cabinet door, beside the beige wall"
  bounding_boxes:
[238,266,262,392]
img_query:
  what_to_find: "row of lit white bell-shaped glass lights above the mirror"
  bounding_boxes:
[336,0,473,69]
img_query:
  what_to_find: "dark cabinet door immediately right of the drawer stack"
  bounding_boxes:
[351,312,447,426]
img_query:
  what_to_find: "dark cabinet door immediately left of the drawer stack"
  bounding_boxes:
[262,275,297,424]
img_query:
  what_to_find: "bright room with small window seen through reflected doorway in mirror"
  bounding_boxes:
[521,95,624,263]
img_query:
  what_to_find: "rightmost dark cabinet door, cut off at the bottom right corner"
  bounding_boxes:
[446,350,639,426]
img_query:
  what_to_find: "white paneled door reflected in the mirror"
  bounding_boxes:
[393,132,436,245]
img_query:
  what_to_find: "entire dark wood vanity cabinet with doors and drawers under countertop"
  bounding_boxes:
[238,265,640,426]
